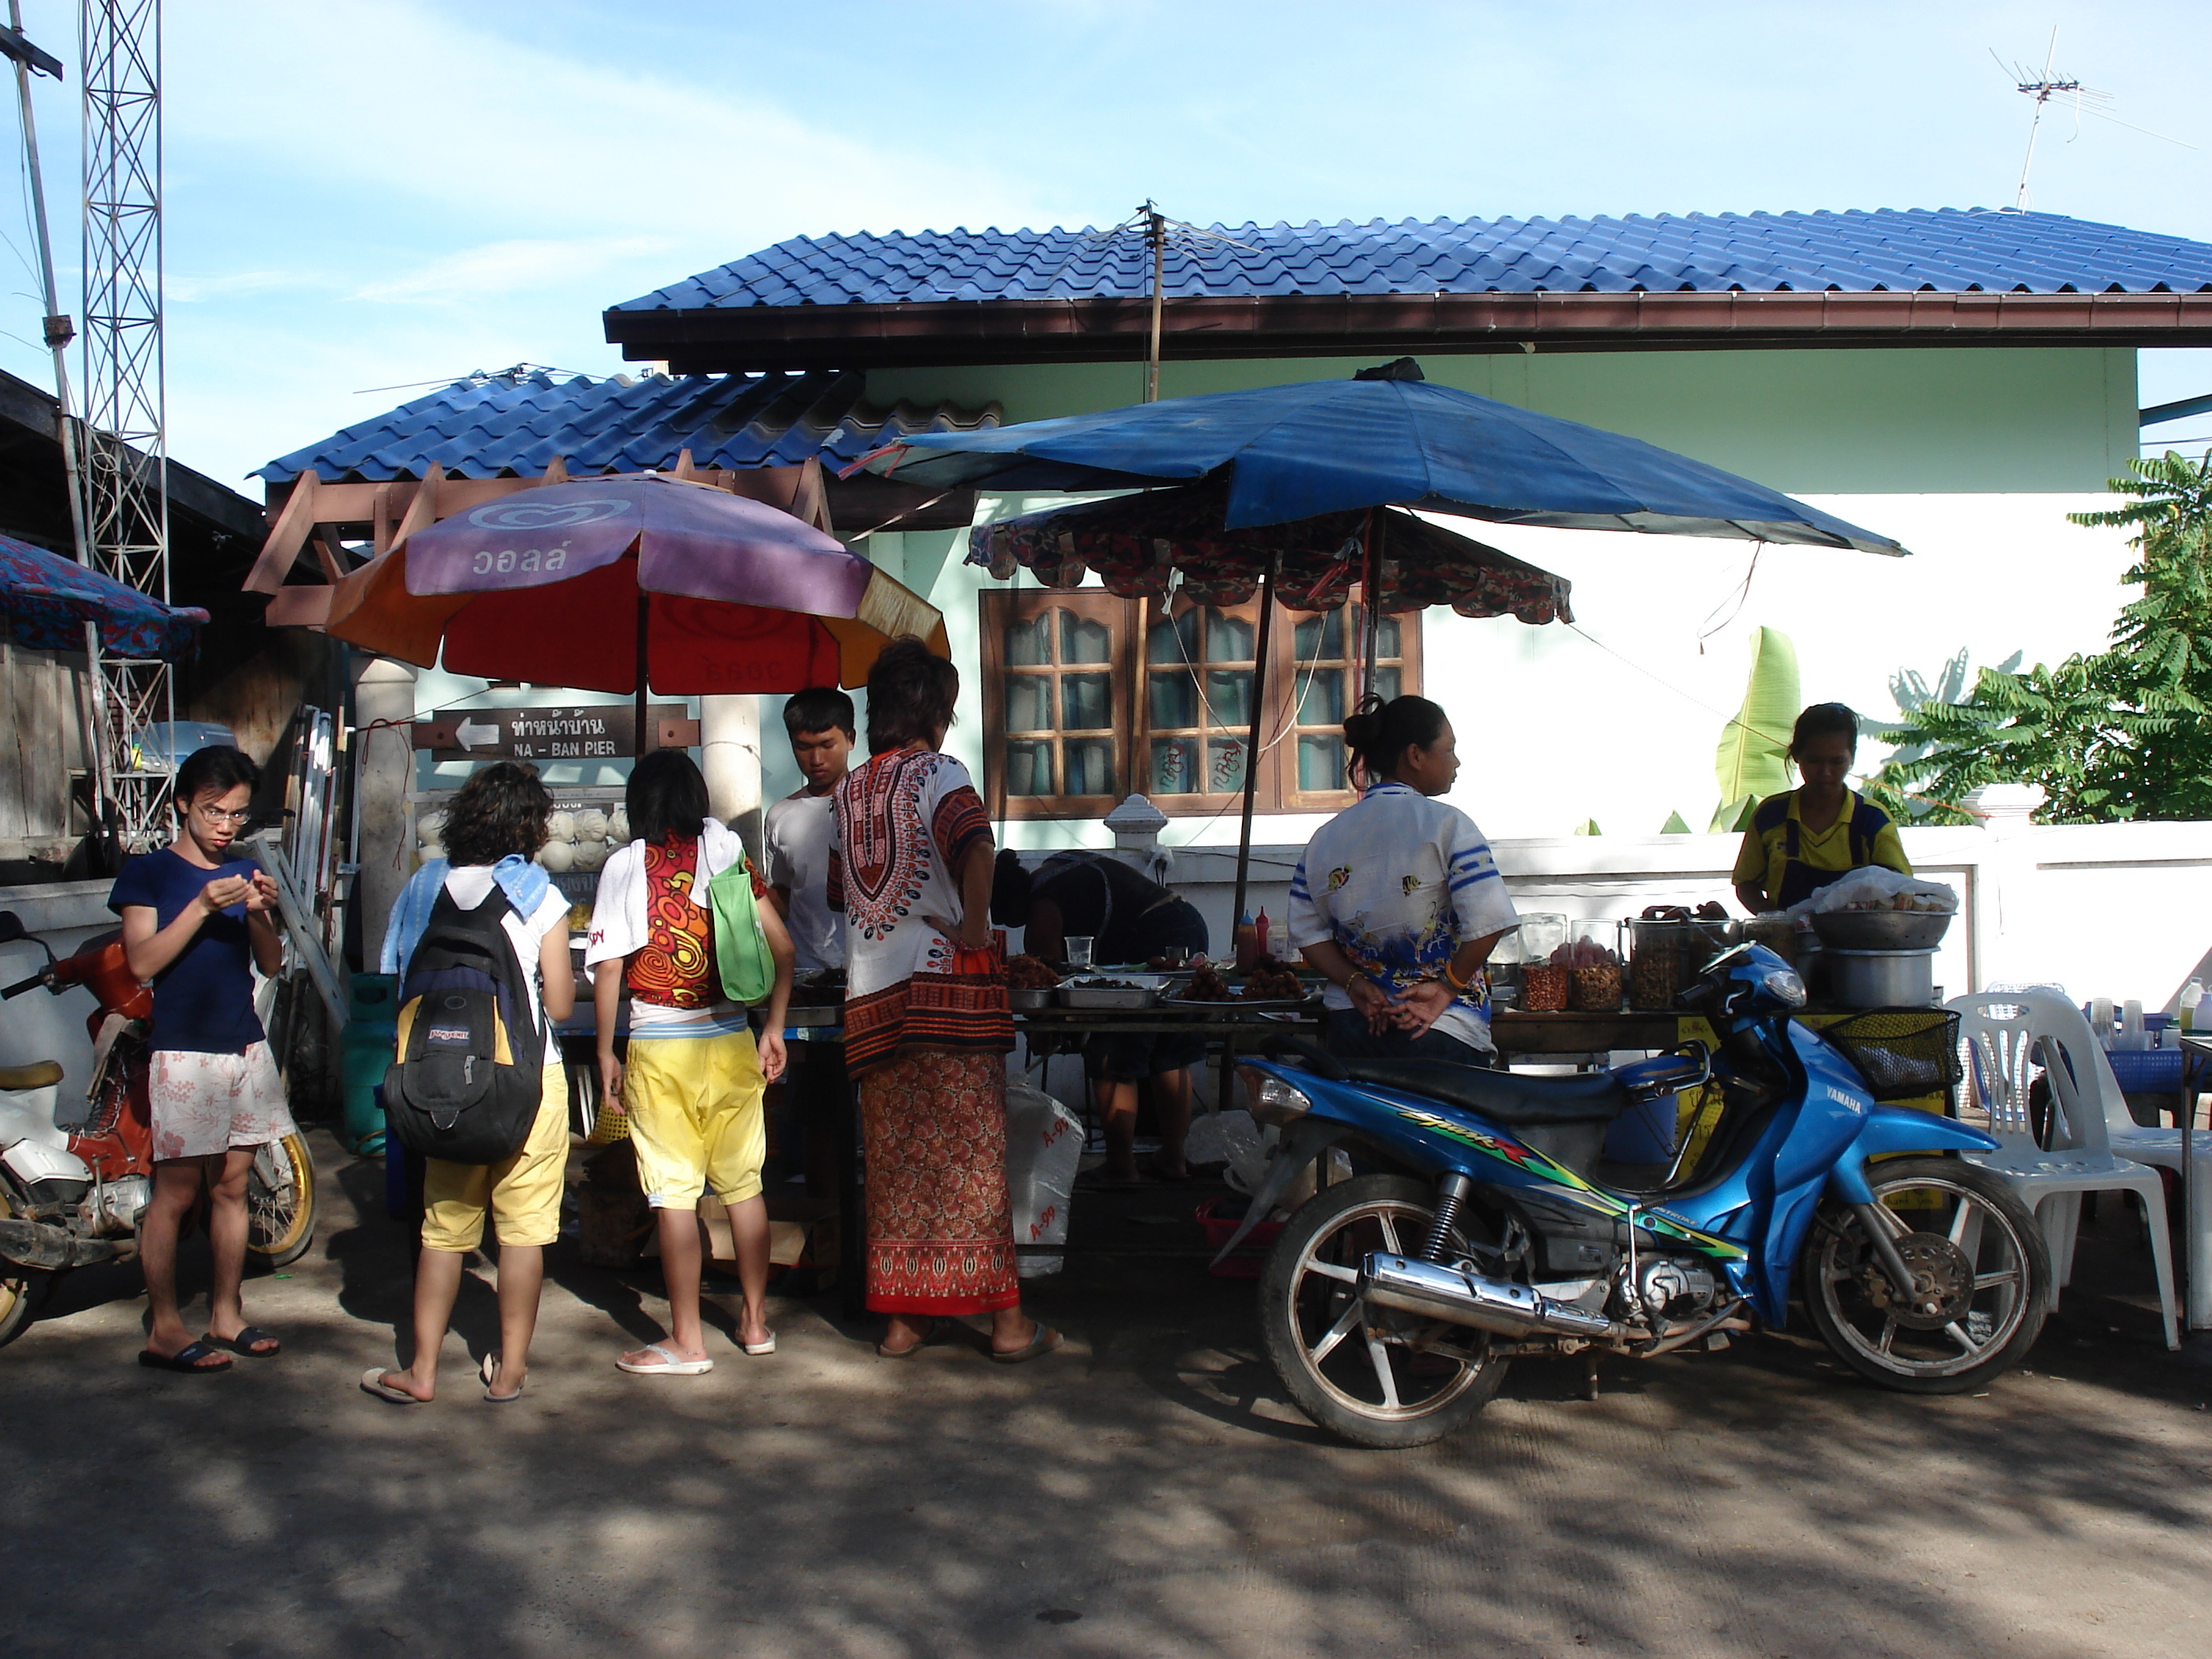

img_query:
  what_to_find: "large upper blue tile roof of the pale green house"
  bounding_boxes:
[613,208,2212,312]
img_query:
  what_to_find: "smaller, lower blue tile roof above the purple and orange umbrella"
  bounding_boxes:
[257,369,998,485]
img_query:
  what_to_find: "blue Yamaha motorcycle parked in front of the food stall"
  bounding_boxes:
[1223,944,2050,1447]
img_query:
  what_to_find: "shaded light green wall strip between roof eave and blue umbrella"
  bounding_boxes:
[867,347,2137,496]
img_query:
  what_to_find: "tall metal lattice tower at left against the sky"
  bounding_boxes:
[78,0,174,849]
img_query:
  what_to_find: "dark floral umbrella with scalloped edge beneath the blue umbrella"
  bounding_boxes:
[967,482,1575,624]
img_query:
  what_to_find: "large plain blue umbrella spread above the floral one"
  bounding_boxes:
[860,358,1905,553]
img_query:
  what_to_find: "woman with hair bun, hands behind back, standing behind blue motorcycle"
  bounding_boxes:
[1290,694,1520,1066]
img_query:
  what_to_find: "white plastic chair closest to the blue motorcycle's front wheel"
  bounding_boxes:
[1946,991,2181,1350]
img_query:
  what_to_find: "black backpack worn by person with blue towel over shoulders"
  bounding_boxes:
[385,887,544,1163]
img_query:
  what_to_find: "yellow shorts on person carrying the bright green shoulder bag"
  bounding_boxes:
[621,1031,767,1210]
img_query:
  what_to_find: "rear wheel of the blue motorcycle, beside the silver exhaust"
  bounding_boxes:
[1258,1174,1507,1448]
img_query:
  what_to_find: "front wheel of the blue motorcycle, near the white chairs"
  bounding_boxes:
[1800,1157,2050,1393]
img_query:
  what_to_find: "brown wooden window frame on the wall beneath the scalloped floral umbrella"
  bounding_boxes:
[978,588,1423,821]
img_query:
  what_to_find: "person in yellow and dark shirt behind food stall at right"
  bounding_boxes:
[1734,703,1914,916]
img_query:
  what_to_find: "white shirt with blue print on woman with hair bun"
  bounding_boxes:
[1290,783,1520,1049]
